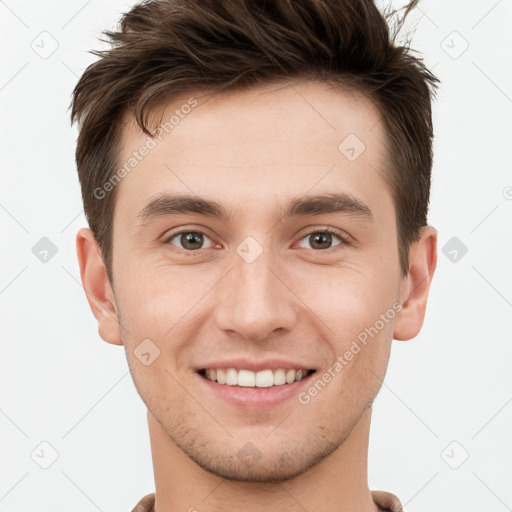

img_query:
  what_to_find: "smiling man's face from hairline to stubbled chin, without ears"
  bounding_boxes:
[98,82,410,481]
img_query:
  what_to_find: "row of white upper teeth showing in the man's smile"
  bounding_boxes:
[205,368,308,388]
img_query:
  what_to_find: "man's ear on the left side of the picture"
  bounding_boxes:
[76,228,123,345]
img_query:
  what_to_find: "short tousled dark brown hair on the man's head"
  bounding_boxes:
[71,0,439,282]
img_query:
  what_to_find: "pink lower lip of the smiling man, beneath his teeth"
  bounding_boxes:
[196,365,316,410]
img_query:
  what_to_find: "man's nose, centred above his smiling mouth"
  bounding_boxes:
[215,245,299,341]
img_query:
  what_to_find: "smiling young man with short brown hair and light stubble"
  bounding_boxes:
[72,0,438,512]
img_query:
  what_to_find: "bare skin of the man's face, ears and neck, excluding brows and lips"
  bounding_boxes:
[77,81,437,512]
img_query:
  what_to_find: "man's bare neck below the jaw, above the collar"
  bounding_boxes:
[148,408,379,512]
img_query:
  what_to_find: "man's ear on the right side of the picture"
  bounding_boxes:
[394,226,437,341]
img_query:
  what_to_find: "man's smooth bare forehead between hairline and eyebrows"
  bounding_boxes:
[116,78,389,226]
